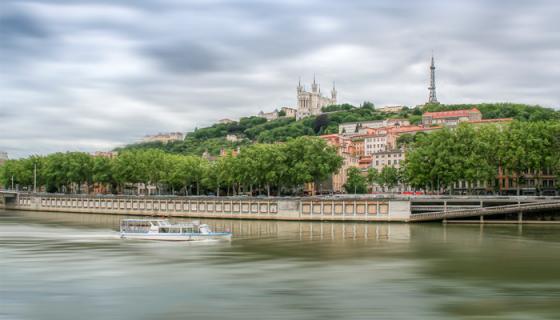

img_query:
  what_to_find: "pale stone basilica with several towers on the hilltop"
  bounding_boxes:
[297,77,337,119]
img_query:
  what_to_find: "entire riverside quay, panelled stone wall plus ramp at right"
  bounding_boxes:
[0,191,560,223]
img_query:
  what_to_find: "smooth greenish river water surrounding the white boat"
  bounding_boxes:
[0,211,560,320]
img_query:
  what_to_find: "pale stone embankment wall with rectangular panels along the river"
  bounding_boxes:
[6,194,410,221]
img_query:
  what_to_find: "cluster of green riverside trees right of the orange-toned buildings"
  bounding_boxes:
[403,121,560,194]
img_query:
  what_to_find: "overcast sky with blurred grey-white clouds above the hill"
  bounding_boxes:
[0,0,560,158]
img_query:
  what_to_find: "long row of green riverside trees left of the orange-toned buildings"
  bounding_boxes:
[0,137,342,195]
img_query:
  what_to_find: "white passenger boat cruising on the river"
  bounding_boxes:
[120,219,231,241]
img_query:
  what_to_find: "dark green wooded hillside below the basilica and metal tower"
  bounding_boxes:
[120,102,560,155]
